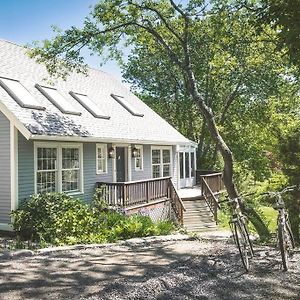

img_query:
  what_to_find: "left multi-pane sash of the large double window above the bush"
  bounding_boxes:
[36,148,57,193]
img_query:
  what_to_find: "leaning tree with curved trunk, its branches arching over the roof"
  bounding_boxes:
[32,0,278,237]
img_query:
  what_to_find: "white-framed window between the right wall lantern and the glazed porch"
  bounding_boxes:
[152,148,171,178]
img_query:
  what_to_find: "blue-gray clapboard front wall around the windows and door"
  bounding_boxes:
[18,138,178,206]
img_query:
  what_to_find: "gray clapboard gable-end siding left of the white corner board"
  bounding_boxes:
[0,112,11,224]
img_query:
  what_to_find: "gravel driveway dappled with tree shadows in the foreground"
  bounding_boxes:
[0,236,300,300]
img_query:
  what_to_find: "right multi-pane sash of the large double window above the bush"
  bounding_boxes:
[62,148,80,192]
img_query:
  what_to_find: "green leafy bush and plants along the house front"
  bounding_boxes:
[12,193,174,245]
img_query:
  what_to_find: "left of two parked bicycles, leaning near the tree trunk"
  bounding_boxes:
[218,195,254,272]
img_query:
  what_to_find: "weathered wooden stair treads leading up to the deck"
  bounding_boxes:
[182,196,217,232]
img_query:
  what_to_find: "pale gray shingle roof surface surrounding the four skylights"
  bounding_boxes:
[0,40,190,145]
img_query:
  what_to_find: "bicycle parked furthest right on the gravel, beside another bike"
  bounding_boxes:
[263,186,296,271]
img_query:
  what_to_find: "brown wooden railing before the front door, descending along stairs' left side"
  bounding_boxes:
[97,177,185,223]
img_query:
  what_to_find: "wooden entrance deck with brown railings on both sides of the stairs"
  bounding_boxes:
[97,172,223,224]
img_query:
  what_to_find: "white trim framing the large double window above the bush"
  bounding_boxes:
[34,142,84,196]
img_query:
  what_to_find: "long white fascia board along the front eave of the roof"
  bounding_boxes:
[29,135,190,146]
